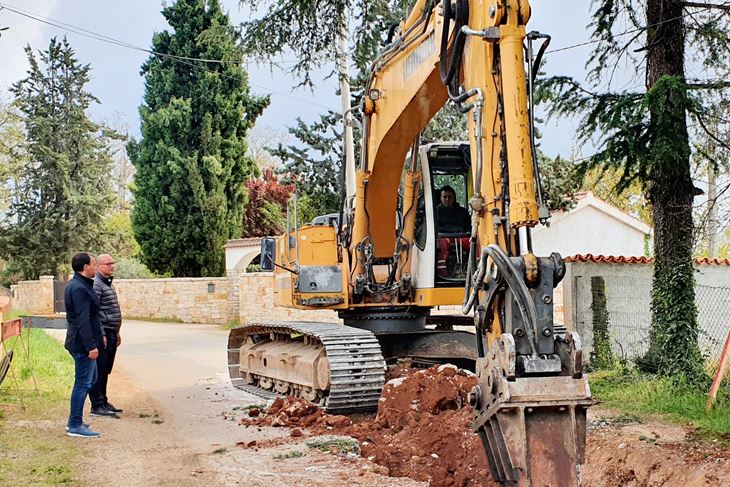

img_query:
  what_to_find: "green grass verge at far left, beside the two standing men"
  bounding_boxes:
[0,328,81,486]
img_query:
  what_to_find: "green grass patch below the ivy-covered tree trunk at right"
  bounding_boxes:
[590,369,730,442]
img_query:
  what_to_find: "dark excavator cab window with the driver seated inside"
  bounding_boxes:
[429,144,472,287]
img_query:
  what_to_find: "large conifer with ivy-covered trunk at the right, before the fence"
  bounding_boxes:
[542,0,730,382]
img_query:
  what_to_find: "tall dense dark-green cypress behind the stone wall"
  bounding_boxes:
[128,0,269,276]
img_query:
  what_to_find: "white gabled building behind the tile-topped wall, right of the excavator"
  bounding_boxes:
[532,192,652,257]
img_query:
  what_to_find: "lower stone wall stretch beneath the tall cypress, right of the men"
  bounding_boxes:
[114,277,233,324]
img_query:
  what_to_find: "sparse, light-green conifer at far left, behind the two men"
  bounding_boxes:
[0,38,112,279]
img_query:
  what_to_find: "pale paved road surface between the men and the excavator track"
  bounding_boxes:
[48,320,265,451]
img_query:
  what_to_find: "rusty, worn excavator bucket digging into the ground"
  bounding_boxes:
[470,333,593,487]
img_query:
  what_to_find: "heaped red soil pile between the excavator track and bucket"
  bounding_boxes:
[241,365,497,487]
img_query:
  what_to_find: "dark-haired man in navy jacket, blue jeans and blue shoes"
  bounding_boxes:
[63,252,104,438]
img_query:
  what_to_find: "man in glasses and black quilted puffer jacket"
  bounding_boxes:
[89,254,122,416]
